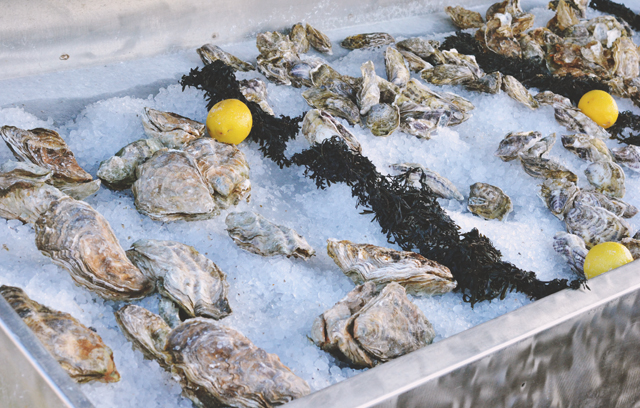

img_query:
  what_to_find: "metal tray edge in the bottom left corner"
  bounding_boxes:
[0,296,93,408]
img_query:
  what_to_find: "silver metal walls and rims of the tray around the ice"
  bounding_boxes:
[0,0,640,408]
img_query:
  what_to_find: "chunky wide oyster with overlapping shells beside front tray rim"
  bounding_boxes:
[311,282,435,367]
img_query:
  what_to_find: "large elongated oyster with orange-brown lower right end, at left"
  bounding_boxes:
[35,197,153,300]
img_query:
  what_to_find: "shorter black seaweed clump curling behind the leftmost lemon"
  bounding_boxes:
[180,61,302,168]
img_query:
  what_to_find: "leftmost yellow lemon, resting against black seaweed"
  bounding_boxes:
[206,99,253,144]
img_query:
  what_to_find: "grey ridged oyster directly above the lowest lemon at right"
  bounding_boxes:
[564,203,631,248]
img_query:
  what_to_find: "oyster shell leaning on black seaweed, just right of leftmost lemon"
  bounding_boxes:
[302,109,362,153]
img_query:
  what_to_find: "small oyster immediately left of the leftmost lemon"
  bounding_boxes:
[142,108,205,149]
